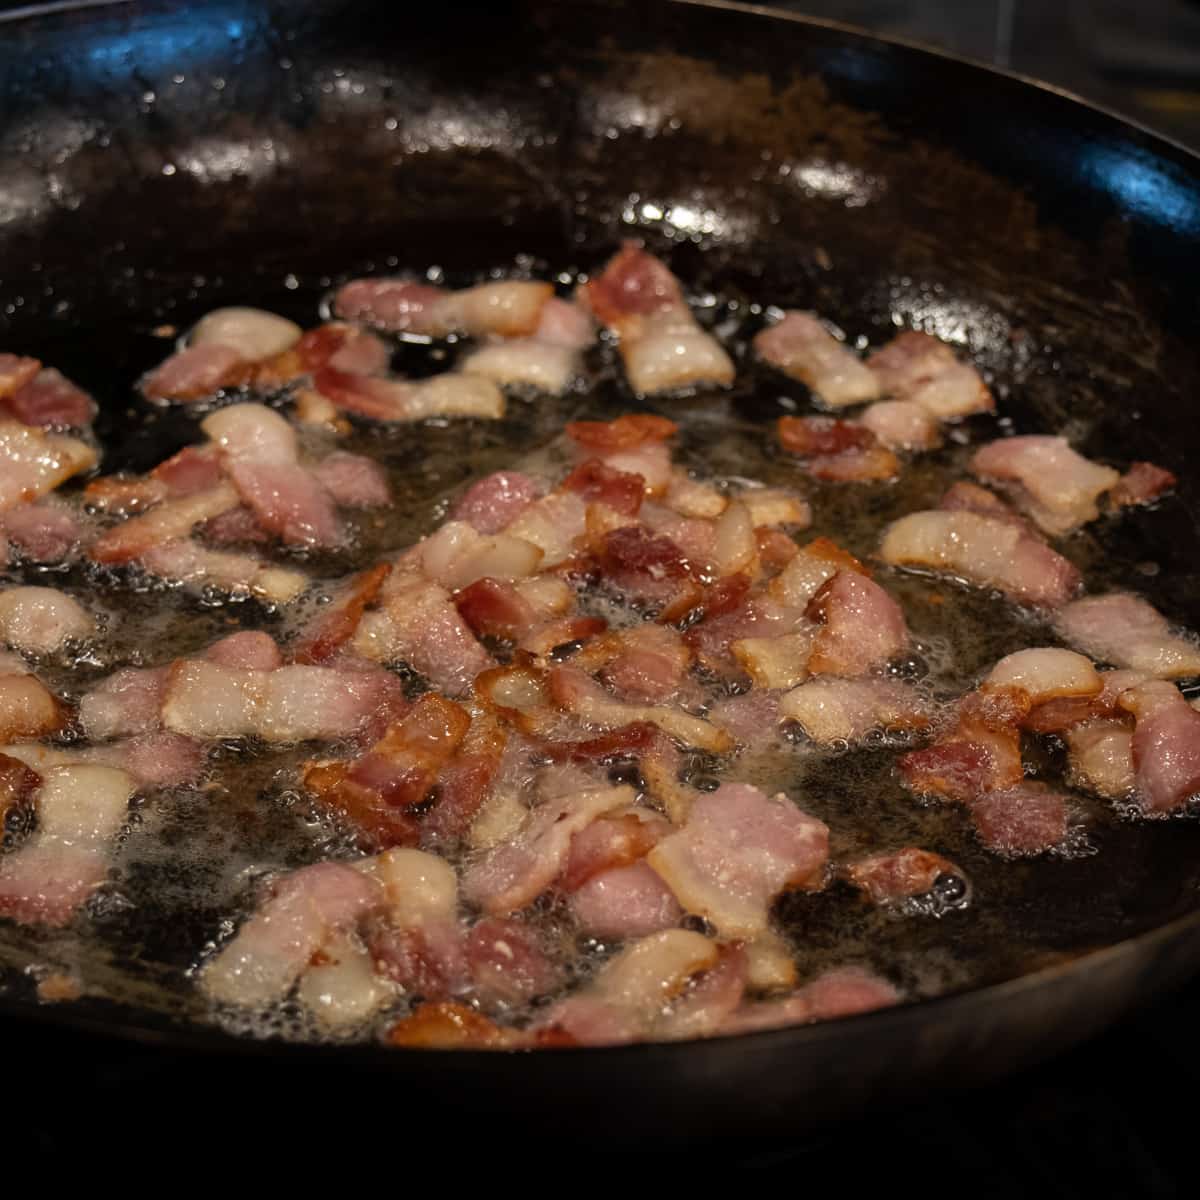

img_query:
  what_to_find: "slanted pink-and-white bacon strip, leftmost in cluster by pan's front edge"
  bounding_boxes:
[199,863,383,1008]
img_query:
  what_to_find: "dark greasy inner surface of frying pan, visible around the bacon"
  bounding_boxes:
[0,0,1200,1113]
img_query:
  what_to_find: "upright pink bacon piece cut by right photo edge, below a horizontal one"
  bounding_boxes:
[1120,679,1200,812]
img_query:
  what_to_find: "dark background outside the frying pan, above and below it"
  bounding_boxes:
[0,0,1200,1180]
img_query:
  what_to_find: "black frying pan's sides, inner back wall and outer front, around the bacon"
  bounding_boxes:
[0,0,1200,1138]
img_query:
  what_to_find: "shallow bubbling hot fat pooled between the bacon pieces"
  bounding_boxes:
[0,270,1200,1037]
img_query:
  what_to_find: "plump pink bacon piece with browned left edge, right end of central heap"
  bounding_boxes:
[805,571,908,676]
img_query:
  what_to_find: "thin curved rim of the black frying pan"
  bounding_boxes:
[0,0,1200,1069]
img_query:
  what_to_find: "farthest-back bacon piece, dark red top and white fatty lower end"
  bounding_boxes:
[581,242,734,396]
